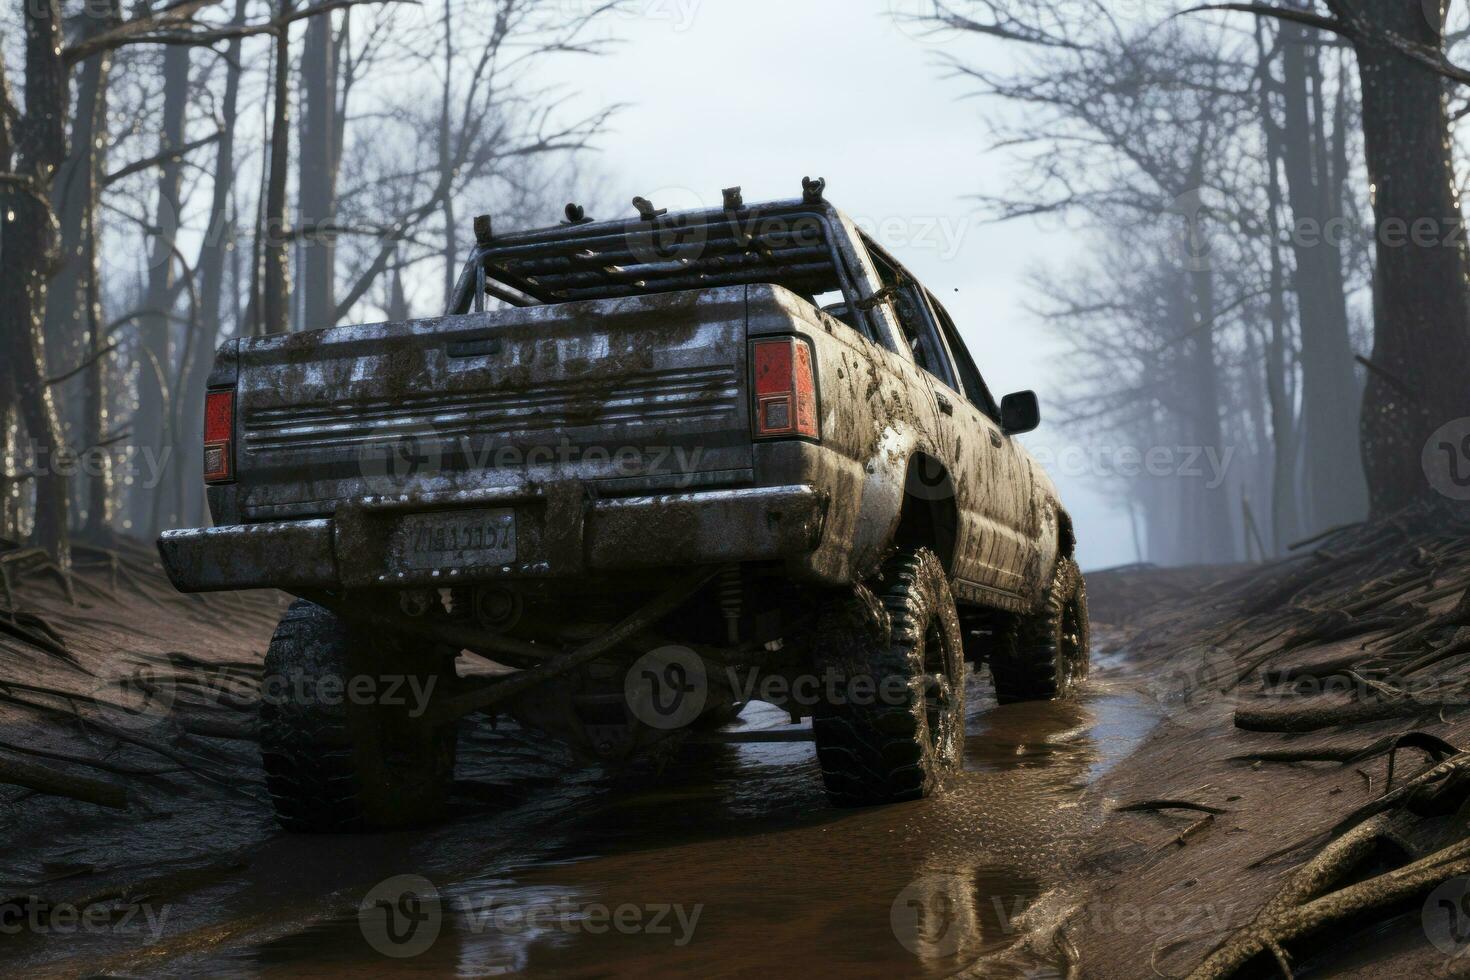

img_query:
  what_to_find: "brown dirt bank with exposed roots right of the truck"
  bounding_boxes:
[1032,511,1470,977]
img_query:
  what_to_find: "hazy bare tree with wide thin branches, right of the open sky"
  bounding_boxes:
[923,0,1260,560]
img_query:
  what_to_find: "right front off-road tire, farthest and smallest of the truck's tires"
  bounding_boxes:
[989,558,1091,704]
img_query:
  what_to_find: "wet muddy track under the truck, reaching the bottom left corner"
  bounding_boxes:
[0,543,1158,977]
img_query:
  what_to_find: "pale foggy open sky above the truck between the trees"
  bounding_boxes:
[547,0,1128,569]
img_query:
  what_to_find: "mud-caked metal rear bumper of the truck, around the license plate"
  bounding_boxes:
[159,485,828,592]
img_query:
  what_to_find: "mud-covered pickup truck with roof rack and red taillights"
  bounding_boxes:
[159,181,1088,832]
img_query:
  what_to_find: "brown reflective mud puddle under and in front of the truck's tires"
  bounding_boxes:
[156,646,1157,977]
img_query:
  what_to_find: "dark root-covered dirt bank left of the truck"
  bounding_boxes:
[0,541,285,965]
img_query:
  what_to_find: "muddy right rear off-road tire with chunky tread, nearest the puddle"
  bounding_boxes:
[811,548,964,807]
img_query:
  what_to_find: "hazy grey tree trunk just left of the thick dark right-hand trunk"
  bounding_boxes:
[1280,24,1367,532]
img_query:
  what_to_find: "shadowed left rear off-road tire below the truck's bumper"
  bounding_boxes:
[259,599,456,833]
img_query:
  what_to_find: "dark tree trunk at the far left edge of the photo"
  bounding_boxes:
[0,0,71,566]
